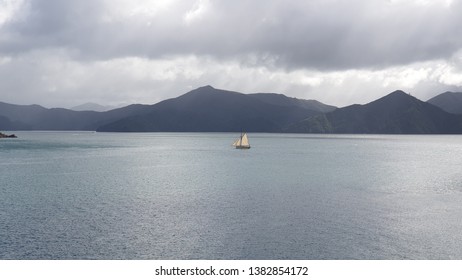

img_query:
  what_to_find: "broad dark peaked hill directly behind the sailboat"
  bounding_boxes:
[98,86,320,132]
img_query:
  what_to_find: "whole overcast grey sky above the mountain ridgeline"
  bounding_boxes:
[0,0,462,107]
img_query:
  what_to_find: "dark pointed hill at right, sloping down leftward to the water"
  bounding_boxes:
[286,91,462,134]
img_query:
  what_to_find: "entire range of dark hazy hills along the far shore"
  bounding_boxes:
[0,86,462,134]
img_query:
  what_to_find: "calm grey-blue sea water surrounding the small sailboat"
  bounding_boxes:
[0,131,462,260]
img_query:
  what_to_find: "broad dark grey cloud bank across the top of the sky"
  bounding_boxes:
[0,0,462,70]
